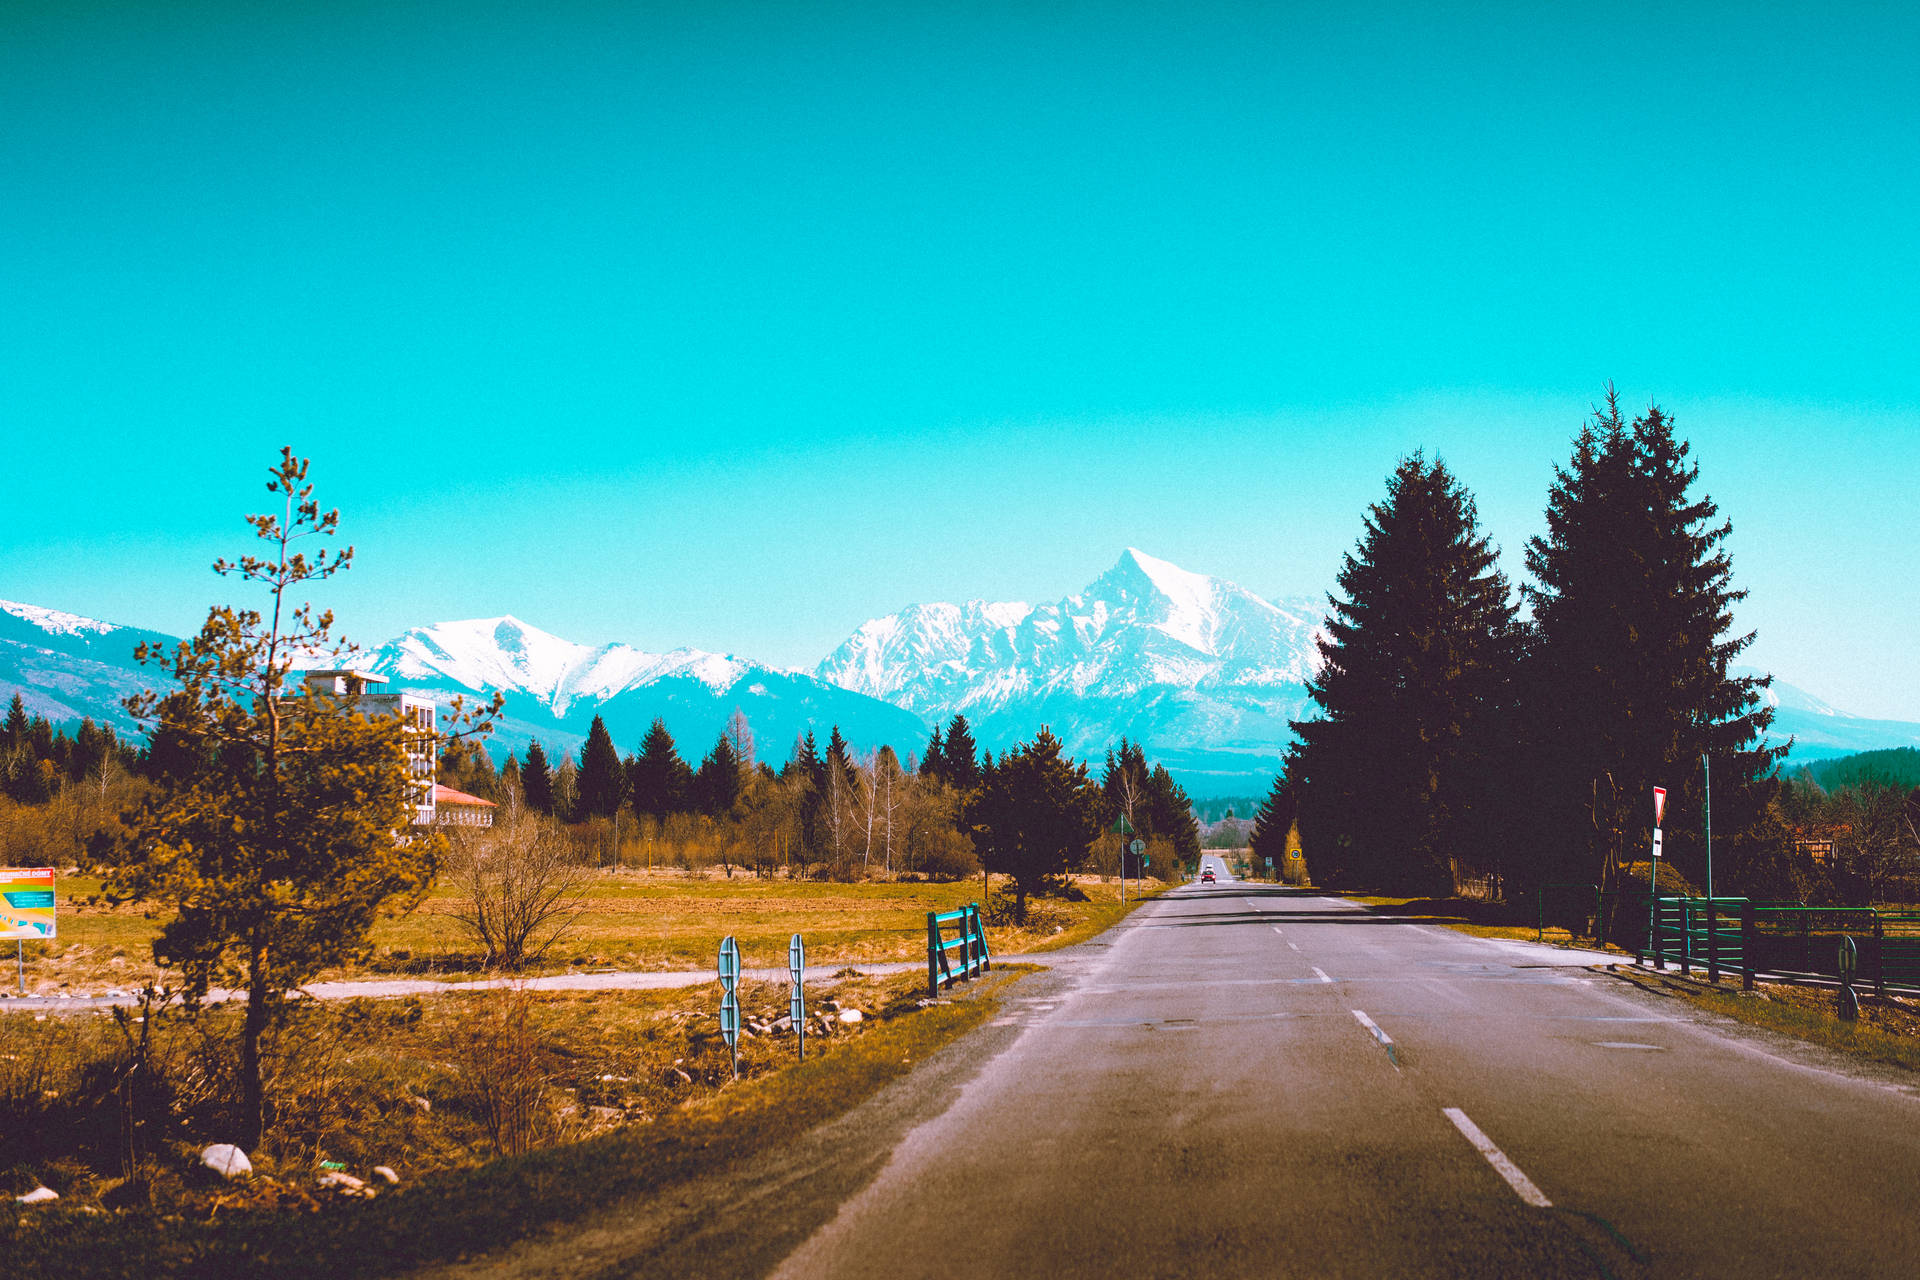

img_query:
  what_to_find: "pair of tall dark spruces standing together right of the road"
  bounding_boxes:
[1254,388,1788,894]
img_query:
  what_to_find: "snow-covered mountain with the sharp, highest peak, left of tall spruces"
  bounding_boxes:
[818,547,1321,787]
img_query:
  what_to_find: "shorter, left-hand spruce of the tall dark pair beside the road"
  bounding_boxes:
[1288,453,1517,894]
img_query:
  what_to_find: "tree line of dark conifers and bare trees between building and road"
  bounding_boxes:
[440,710,1200,915]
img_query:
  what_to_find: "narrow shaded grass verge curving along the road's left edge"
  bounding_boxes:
[0,967,1025,1280]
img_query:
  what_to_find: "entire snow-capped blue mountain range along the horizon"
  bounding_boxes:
[0,549,1920,796]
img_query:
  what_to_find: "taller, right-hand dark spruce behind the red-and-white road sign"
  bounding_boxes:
[1521,395,1784,887]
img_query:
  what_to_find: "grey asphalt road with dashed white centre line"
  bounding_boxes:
[435,855,1920,1280]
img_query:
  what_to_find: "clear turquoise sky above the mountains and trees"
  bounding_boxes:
[11,2,1920,720]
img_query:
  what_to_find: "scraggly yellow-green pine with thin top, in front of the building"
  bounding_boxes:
[106,449,499,1148]
